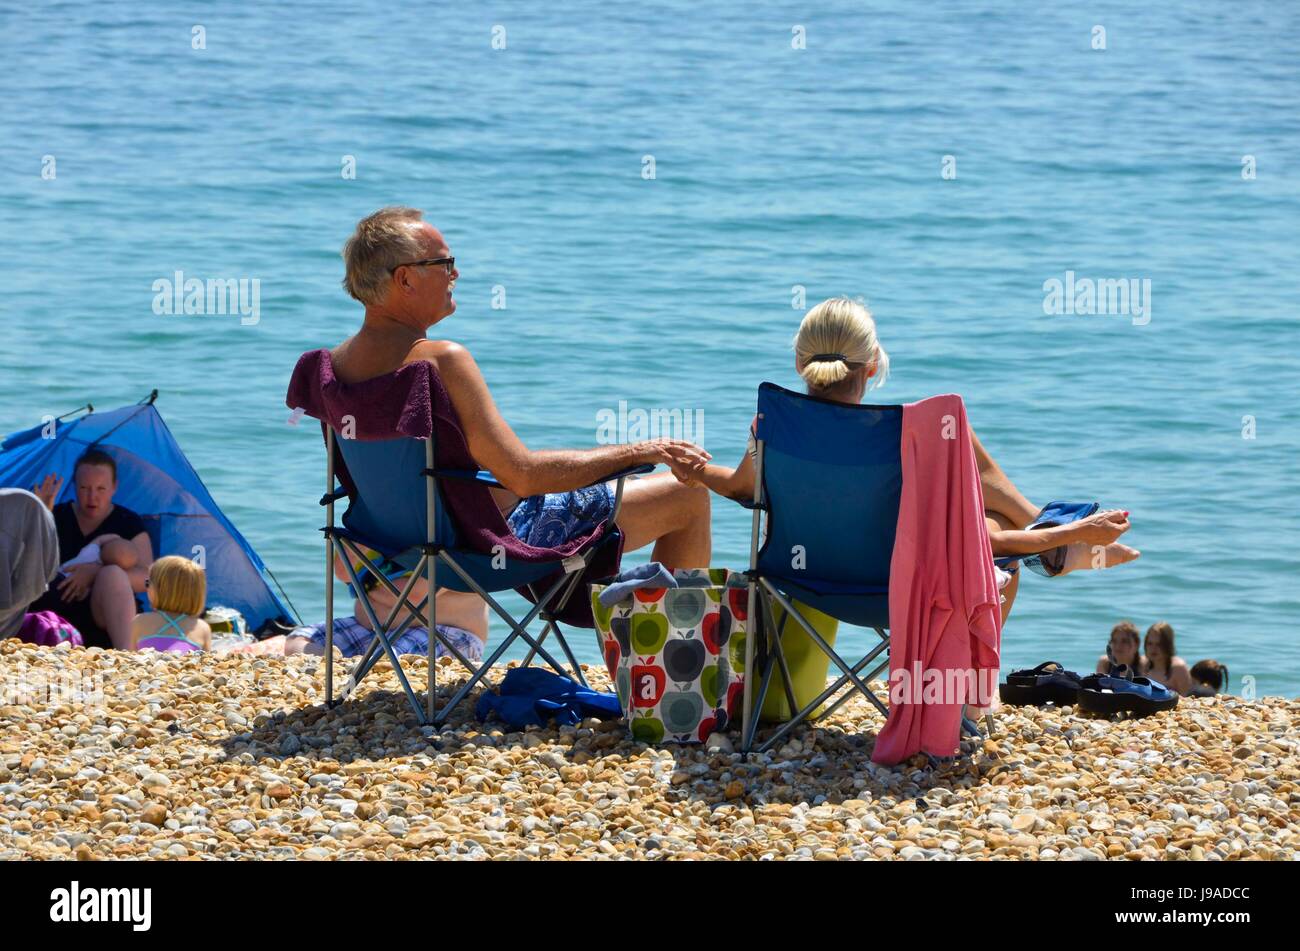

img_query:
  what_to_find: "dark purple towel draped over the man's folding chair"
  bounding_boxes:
[285,349,623,628]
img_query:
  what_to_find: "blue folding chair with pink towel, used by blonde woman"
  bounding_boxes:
[742,383,902,751]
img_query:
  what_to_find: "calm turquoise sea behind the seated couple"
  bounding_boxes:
[0,0,1300,696]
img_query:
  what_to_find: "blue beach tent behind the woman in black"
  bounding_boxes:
[0,390,294,631]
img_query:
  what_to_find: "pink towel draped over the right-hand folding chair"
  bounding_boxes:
[872,394,1002,765]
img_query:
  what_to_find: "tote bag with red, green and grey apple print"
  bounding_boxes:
[592,568,749,743]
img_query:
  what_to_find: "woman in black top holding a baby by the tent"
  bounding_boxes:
[29,450,153,650]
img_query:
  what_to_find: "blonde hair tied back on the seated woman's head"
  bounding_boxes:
[794,298,889,390]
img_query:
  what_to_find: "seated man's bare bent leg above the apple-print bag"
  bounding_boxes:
[618,473,712,568]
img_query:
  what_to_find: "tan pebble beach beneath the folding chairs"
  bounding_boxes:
[0,639,1300,860]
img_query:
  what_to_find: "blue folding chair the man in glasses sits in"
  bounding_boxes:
[313,426,644,725]
